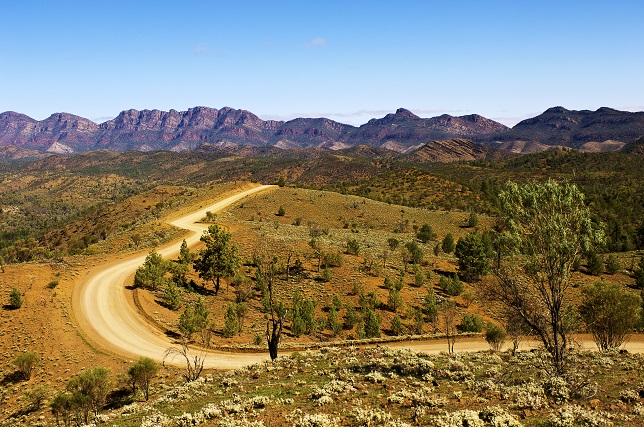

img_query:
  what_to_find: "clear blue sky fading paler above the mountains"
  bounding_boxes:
[0,0,644,125]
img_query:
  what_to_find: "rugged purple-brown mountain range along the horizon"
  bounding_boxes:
[0,107,644,157]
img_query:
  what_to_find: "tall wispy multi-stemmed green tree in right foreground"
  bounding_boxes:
[486,180,603,375]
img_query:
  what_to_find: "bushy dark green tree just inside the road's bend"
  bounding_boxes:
[194,224,241,295]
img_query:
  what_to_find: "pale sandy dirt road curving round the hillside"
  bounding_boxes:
[73,185,644,369]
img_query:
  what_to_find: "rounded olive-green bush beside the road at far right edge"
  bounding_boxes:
[579,280,642,350]
